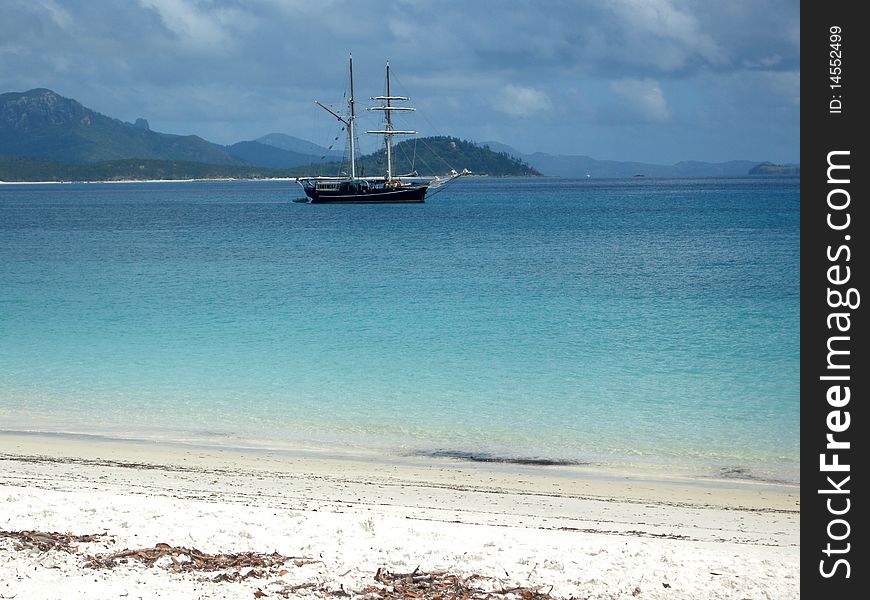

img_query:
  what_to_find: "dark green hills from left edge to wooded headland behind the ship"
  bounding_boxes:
[0,88,539,181]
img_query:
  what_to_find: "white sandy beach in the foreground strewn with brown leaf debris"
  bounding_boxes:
[0,433,800,600]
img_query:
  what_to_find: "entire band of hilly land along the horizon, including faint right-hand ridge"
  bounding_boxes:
[0,88,800,182]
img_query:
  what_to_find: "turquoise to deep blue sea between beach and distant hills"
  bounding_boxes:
[0,178,800,481]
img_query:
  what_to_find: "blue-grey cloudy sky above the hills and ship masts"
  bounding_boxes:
[0,0,800,164]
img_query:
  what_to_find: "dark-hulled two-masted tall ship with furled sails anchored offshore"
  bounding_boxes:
[296,55,468,204]
